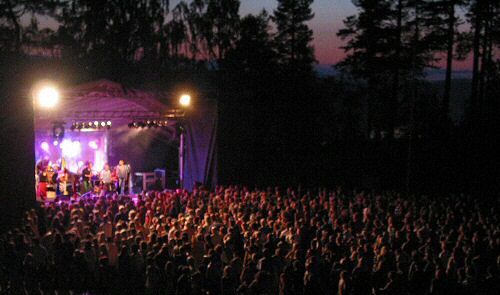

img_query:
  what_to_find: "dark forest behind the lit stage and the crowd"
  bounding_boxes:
[0,0,500,193]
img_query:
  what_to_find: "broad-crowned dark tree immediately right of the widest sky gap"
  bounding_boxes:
[337,0,448,134]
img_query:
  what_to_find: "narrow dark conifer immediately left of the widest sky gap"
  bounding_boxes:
[272,0,316,75]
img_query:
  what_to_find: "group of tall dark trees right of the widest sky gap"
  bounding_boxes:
[337,0,500,134]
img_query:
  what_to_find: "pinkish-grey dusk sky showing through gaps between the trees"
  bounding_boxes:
[36,0,471,70]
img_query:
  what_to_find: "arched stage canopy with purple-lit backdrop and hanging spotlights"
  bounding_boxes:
[35,80,217,189]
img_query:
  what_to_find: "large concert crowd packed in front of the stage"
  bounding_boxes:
[0,186,500,295]
